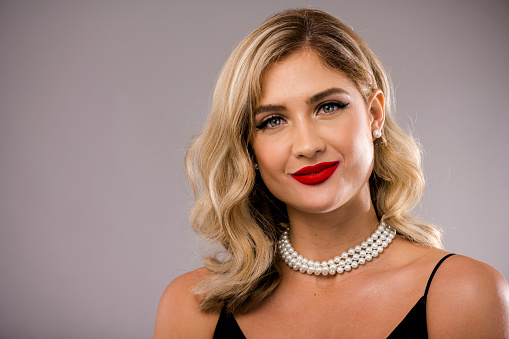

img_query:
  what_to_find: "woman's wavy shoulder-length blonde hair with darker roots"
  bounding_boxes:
[186,9,441,313]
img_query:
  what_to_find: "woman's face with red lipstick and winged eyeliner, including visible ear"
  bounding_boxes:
[253,50,384,213]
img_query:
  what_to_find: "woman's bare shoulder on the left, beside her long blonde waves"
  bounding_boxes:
[154,268,219,339]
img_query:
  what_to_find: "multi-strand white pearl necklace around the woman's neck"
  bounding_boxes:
[278,222,396,275]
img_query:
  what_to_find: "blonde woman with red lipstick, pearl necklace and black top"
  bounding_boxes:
[155,9,509,338]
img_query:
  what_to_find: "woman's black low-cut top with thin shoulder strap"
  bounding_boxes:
[214,253,454,339]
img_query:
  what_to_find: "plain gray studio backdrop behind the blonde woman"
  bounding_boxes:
[0,0,509,338]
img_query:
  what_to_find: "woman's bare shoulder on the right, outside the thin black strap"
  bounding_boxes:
[426,255,509,338]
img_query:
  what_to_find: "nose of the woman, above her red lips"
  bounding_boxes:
[292,122,326,158]
